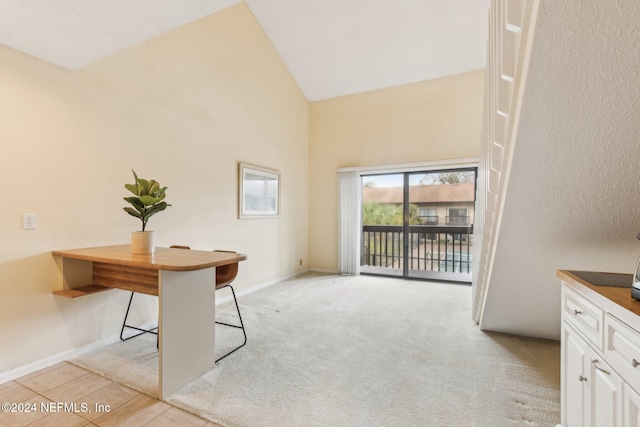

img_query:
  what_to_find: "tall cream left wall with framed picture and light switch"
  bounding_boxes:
[0,3,309,374]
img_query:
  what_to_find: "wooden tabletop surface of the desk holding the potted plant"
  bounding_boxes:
[53,245,247,271]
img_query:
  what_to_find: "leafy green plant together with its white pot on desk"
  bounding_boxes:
[124,169,171,254]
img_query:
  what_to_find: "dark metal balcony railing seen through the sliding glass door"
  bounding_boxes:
[360,225,473,275]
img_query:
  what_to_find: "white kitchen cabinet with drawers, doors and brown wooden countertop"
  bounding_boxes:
[559,274,640,427]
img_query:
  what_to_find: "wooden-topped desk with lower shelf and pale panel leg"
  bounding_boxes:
[53,245,247,399]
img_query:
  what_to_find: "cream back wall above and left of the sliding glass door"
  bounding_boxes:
[309,70,484,271]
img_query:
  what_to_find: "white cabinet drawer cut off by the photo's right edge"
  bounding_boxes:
[604,314,640,390]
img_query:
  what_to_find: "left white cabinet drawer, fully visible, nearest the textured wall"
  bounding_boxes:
[562,285,604,350]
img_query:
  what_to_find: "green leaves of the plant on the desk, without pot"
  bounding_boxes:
[124,169,171,231]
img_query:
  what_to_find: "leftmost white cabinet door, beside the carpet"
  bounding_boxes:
[561,324,588,427]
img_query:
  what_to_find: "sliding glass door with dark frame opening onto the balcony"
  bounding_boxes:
[360,168,476,282]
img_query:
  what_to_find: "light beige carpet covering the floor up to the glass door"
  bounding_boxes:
[71,274,560,427]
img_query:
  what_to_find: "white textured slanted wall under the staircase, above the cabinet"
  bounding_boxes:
[481,0,640,338]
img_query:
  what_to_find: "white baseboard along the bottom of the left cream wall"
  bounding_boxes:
[0,270,306,384]
